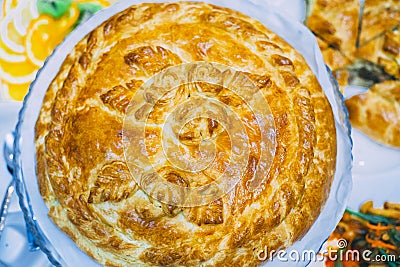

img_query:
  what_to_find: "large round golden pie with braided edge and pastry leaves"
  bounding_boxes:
[35,2,336,266]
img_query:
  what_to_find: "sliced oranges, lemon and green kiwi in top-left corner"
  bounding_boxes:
[0,0,112,101]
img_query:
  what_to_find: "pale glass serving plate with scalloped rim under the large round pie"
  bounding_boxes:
[11,0,352,266]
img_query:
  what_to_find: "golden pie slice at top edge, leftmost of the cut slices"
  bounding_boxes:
[306,0,360,58]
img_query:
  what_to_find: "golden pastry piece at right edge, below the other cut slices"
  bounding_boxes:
[346,81,400,147]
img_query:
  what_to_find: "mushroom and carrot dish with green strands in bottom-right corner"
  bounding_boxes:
[326,201,400,267]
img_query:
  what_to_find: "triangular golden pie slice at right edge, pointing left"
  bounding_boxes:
[356,29,400,78]
